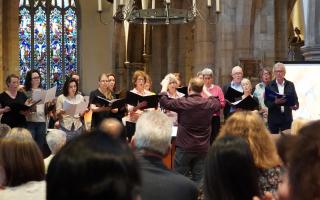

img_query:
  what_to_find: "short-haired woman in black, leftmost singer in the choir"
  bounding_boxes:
[0,74,29,128]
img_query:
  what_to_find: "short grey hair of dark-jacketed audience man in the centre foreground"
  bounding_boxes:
[134,111,173,155]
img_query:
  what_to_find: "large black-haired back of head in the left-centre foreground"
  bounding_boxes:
[47,132,141,200]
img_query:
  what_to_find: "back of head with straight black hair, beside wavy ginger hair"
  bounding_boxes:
[204,136,259,200]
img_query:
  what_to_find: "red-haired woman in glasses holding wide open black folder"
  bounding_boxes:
[125,70,154,141]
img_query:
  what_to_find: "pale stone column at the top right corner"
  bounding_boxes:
[301,0,320,61]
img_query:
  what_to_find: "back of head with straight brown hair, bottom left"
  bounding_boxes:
[0,128,45,187]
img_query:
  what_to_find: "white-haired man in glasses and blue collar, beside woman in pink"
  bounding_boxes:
[222,66,243,120]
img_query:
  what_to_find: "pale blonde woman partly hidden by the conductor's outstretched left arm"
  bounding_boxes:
[160,73,184,126]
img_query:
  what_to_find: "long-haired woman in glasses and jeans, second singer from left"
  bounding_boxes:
[24,69,46,149]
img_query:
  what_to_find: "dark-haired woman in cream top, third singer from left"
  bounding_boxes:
[56,79,85,141]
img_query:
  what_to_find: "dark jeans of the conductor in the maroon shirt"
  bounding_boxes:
[174,147,207,186]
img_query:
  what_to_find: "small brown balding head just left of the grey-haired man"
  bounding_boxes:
[100,118,125,138]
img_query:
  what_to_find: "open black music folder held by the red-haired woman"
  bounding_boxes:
[126,91,160,108]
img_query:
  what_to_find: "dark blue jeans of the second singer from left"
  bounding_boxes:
[27,122,46,150]
